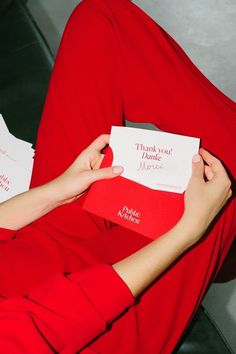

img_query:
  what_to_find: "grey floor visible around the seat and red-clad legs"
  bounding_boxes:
[28,0,236,354]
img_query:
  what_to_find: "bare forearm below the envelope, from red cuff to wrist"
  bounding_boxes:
[113,218,197,296]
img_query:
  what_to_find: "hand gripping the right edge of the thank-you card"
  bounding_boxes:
[183,148,232,238]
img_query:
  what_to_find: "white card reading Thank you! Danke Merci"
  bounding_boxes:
[110,126,200,193]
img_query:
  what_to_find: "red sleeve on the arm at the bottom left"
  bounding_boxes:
[0,264,134,354]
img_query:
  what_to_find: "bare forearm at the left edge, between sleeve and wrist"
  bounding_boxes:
[0,183,60,230]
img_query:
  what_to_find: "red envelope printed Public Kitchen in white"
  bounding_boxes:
[82,147,184,239]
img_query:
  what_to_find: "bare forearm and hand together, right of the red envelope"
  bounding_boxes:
[113,149,232,296]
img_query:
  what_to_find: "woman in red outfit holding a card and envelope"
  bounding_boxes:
[0,0,236,354]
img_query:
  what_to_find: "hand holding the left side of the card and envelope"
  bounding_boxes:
[49,134,123,205]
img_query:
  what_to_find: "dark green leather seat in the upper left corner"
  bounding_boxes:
[0,0,54,147]
